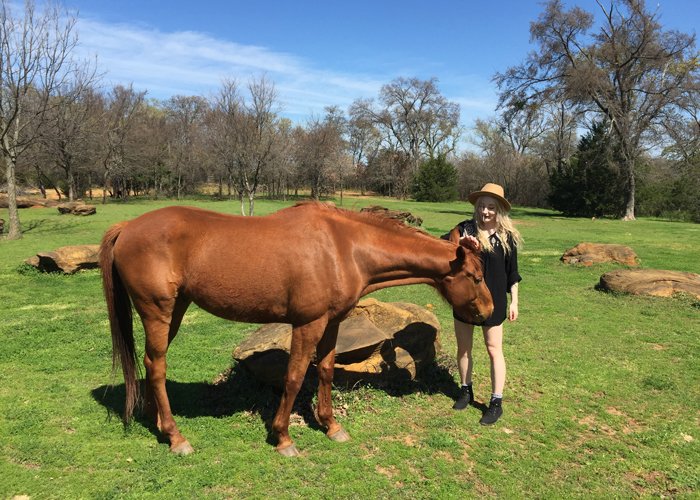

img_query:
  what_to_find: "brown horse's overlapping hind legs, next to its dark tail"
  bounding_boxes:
[139,301,194,455]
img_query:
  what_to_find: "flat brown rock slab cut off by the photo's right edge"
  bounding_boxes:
[599,269,700,299]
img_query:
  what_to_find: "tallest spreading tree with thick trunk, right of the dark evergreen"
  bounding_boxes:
[495,0,700,220]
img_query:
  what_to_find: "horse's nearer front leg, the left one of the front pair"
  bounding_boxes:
[272,316,328,456]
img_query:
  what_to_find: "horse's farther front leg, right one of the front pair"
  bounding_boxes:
[316,323,350,442]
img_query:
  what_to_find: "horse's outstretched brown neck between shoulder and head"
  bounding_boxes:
[356,223,452,293]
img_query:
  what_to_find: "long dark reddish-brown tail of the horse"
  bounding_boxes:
[100,223,140,422]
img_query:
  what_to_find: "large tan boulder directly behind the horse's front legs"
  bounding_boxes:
[233,299,440,387]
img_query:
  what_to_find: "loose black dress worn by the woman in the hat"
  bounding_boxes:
[443,219,522,326]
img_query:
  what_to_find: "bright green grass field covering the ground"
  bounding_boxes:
[0,197,700,498]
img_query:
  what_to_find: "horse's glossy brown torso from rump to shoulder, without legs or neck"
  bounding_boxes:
[109,206,360,322]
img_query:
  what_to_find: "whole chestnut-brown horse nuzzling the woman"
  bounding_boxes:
[100,203,493,455]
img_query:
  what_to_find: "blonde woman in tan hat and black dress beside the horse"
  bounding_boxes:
[453,183,522,425]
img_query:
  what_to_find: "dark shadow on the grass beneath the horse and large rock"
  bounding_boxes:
[91,359,458,445]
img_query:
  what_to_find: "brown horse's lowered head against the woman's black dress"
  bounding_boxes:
[438,229,493,323]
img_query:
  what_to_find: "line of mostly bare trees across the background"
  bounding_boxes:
[0,0,700,238]
